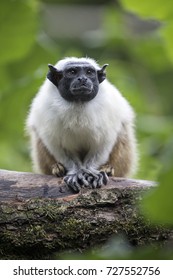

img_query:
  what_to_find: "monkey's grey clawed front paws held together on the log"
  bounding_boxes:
[64,168,108,192]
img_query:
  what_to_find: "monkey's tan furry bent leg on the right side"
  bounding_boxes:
[100,124,137,177]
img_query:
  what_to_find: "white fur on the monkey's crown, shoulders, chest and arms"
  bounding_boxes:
[27,58,134,173]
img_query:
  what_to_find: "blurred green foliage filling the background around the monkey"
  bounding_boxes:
[0,0,173,258]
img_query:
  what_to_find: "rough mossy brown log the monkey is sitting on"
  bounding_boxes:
[0,170,173,259]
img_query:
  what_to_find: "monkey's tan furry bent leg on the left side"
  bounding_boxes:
[32,134,66,177]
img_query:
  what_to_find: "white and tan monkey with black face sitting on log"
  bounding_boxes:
[26,57,137,192]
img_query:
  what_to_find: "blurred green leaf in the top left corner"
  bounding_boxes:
[0,0,37,64]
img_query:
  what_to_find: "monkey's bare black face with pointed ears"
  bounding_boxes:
[47,62,107,102]
